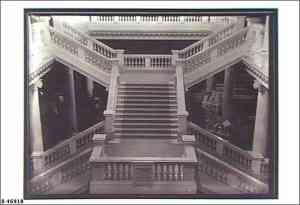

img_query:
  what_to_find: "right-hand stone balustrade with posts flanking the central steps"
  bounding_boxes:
[172,50,188,135]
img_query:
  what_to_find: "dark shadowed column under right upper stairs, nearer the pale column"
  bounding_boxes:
[222,67,234,120]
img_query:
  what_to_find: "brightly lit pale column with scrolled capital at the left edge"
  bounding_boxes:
[29,80,44,170]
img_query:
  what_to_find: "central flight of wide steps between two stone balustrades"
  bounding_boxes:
[113,82,178,138]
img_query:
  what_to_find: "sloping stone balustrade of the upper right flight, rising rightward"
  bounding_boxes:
[180,28,251,73]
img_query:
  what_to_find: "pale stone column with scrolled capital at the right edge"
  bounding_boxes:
[253,81,269,156]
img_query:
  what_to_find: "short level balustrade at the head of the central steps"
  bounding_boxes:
[124,54,172,69]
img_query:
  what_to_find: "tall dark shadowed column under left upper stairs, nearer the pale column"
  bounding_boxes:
[69,69,78,132]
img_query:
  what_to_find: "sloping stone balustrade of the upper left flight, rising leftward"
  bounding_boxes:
[49,27,113,73]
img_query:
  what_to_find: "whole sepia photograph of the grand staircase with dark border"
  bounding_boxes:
[20,8,278,199]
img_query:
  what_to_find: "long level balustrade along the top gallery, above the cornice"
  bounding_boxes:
[91,15,236,24]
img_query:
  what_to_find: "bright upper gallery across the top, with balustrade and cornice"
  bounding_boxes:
[41,14,244,40]
